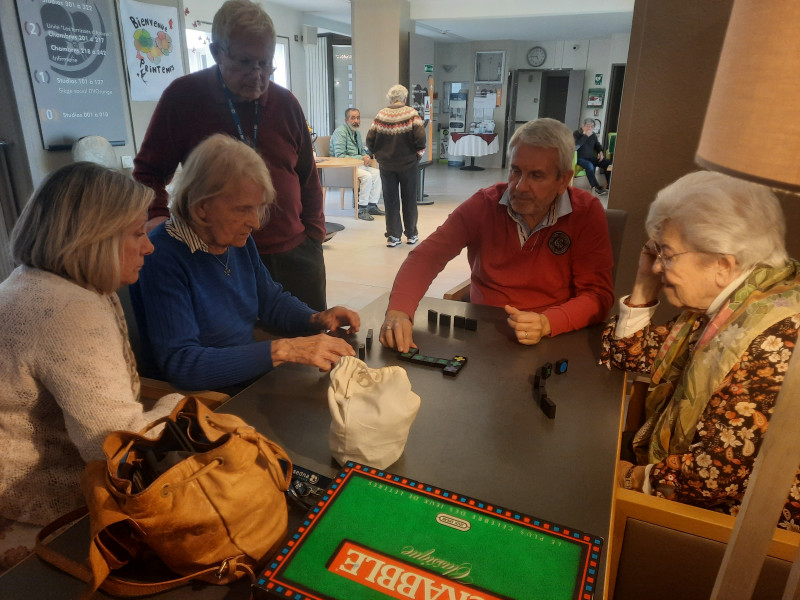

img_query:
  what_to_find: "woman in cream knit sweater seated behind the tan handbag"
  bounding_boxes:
[0,163,181,569]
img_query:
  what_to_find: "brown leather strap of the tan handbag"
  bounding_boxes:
[34,506,250,598]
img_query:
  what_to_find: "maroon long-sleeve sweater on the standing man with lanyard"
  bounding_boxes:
[133,67,325,254]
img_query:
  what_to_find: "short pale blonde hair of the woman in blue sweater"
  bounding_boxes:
[169,133,275,225]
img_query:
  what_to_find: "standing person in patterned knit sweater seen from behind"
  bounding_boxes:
[367,85,426,248]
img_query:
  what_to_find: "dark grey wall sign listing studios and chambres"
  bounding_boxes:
[17,0,127,150]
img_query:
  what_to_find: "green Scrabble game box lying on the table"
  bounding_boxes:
[254,463,603,600]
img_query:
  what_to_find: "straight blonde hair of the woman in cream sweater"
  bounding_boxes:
[11,162,154,294]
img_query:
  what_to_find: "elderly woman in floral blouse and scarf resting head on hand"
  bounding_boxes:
[603,172,800,530]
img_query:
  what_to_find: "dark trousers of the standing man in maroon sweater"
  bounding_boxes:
[261,237,327,312]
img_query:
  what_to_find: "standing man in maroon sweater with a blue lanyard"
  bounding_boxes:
[133,0,326,311]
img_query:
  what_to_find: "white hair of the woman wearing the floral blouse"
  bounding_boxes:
[645,171,788,270]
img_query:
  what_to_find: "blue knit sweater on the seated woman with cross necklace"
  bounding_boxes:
[130,223,315,390]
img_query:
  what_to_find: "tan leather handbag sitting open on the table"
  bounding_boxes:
[37,397,292,595]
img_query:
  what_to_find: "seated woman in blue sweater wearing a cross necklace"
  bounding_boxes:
[131,134,360,389]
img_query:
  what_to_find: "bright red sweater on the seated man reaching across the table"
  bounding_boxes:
[389,183,614,335]
